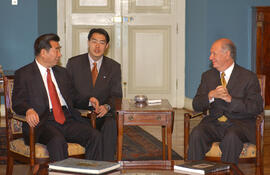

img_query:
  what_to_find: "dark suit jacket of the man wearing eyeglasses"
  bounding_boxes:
[67,53,122,108]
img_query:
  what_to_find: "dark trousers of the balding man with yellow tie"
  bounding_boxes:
[188,117,256,164]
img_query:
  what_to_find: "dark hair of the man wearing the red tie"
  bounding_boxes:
[34,33,60,56]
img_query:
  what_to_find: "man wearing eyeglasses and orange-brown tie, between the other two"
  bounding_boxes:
[67,28,122,161]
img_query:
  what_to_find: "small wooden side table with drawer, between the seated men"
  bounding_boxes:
[116,99,174,161]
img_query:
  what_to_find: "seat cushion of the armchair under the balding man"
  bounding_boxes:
[206,142,256,158]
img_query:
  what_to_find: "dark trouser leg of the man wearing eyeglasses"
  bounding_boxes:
[96,115,117,161]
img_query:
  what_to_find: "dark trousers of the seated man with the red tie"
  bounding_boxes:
[37,108,102,161]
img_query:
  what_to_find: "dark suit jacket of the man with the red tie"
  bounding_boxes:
[12,61,89,143]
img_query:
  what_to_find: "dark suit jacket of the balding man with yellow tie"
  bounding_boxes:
[193,64,263,143]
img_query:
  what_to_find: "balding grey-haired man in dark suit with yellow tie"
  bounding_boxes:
[188,38,263,164]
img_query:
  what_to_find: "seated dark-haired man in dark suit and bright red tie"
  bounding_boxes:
[12,34,102,161]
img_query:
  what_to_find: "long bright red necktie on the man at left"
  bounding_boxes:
[47,69,66,124]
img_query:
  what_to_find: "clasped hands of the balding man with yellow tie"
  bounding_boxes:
[208,86,232,103]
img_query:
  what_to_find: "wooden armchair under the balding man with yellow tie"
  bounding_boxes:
[184,74,266,175]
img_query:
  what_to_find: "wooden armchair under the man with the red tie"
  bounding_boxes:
[3,76,93,175]
